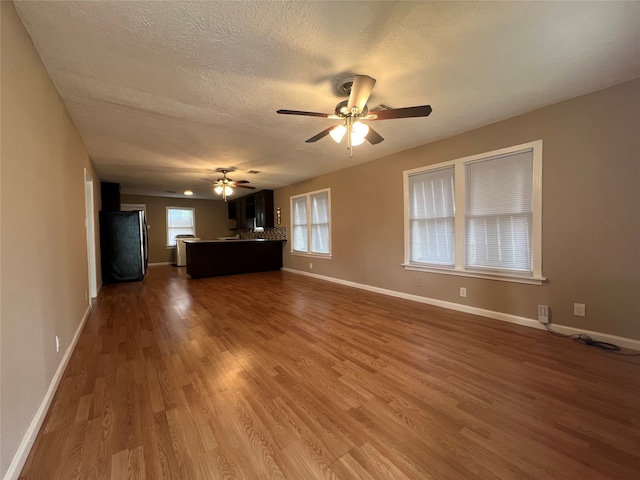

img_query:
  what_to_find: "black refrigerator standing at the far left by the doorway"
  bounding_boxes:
[100,211,148,283]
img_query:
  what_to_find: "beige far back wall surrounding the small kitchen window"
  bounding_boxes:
[120,195,236,263]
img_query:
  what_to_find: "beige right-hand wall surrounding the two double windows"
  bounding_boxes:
[275,80,640,340]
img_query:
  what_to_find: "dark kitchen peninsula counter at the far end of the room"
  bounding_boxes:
[185,238,285,278]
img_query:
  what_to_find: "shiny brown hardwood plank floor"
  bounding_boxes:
[20,266,640,480]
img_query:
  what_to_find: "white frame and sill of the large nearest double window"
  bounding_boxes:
[402,140,546,285]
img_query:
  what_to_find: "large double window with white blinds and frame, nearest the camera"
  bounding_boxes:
[403,140,544,284]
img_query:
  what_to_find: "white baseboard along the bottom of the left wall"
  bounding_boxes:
[3,305,91,480]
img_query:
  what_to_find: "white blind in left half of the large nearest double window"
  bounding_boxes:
[409,165,455,266]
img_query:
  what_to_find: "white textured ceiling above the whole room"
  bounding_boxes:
[16,1,640,198]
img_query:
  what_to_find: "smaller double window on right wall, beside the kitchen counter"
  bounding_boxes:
[291,189,331,256]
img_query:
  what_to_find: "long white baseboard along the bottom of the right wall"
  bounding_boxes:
[282,267,640,351]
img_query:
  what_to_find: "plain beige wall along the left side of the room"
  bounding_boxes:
[0,2,100,477]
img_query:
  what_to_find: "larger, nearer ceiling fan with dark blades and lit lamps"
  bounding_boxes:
[277,75,431,157]
